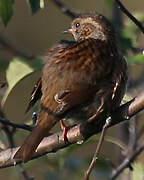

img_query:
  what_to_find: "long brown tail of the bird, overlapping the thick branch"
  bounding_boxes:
[14,126,45,162]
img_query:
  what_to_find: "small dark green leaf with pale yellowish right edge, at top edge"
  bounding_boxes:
[28,0,44,14]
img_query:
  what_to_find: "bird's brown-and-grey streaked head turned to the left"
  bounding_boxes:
[68,13,114,41]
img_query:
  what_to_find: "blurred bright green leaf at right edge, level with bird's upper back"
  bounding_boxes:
[125,53,144,64]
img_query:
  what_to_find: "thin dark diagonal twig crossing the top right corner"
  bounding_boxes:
[115,0,144,33]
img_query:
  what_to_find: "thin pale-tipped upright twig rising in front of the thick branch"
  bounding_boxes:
[84,117,111,180]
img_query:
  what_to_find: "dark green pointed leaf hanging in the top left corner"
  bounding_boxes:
[0,0,14,26]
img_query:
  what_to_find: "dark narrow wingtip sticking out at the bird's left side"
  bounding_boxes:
[25,78,42,113]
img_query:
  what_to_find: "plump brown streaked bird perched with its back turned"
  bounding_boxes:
[14,13,128,162]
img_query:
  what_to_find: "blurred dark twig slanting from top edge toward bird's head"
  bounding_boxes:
[52,0,77,19]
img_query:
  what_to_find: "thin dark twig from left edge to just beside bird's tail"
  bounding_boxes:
[0,117,33,131]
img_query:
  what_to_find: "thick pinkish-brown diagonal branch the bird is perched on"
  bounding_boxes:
[0,92,144,168]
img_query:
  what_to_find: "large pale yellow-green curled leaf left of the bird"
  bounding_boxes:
[2,58,43,105]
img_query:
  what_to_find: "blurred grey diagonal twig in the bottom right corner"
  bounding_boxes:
[109,141,144,180]
